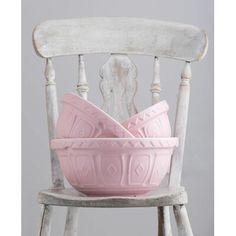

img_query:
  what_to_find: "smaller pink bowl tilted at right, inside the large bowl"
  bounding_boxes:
[122,100,171,138]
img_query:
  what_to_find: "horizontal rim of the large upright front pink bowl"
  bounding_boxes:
[50,137,179,149]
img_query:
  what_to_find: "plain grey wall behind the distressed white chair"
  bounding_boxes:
[22,0,213,236]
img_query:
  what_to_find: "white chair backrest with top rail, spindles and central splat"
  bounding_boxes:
[33,18,207,188]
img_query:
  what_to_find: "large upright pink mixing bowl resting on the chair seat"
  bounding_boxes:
[51,138,178,196]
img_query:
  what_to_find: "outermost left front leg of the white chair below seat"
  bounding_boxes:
[38,205,52,236]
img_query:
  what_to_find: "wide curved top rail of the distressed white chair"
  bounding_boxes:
[33,17,207,61]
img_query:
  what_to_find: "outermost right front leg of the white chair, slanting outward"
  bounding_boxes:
[173,205,193,236]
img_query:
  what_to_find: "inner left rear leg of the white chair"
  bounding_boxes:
[64,207,79,236]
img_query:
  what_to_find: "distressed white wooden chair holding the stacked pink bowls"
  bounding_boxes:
[33,18,207,236]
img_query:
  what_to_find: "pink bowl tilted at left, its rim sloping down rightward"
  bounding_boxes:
[56,93,134,138]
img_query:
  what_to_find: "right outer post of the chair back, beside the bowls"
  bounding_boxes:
[169,62,192,186]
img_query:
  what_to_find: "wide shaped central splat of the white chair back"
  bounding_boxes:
[100,54,137,121]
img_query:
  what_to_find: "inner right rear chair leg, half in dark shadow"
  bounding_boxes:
[158,206,172,236]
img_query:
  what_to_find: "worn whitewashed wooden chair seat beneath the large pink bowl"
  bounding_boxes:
[38,187,187,208]
